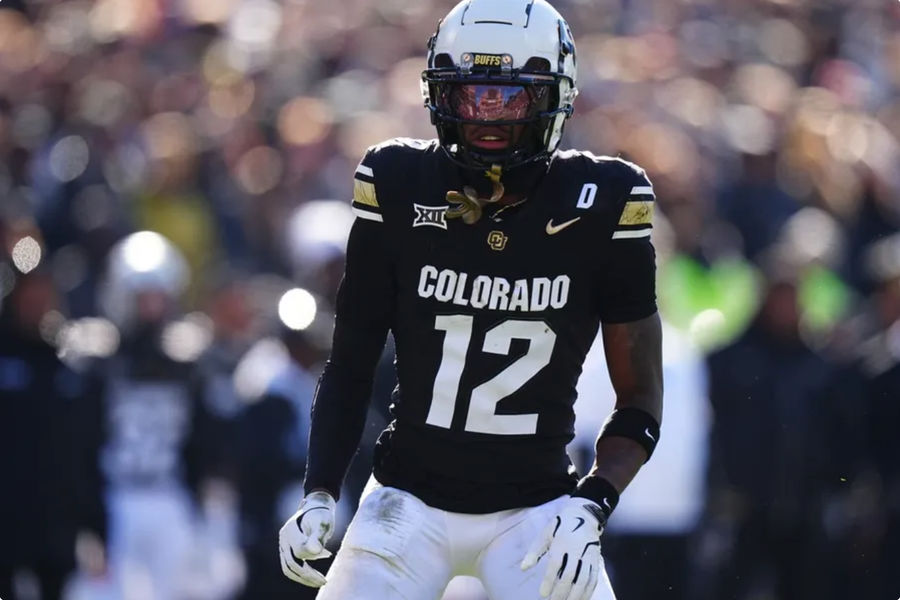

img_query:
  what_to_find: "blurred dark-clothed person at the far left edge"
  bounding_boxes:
[0,268,106,600]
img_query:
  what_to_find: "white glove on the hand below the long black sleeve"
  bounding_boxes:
[278,492,335,587]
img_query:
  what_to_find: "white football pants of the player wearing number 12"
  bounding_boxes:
[317,479,615,600]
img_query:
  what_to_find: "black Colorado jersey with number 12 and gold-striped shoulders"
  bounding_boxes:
[338,139,656,513]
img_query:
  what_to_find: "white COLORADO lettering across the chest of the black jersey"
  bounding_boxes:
[418,265,571,312]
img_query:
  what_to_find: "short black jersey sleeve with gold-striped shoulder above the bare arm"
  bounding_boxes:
[599,163,656,323]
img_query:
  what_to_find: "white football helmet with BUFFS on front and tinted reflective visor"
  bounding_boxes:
[422,0,578,169]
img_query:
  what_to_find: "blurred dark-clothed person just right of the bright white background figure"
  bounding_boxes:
[700,255,839,600]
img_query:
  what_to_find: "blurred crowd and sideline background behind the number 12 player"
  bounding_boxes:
[0,0,900,600]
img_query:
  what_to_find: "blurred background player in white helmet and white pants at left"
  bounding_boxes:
[90,231,217,600]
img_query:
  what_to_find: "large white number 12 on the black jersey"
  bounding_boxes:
[425,315,556,435]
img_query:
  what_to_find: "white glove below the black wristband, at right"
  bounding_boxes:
[520,498,606,600]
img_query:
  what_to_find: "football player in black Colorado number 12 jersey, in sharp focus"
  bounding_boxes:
[279,0,662,600]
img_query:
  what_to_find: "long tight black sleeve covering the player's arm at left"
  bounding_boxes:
[303,218,395,499]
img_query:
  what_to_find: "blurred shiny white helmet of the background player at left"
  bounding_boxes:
[100,231,190,327]
